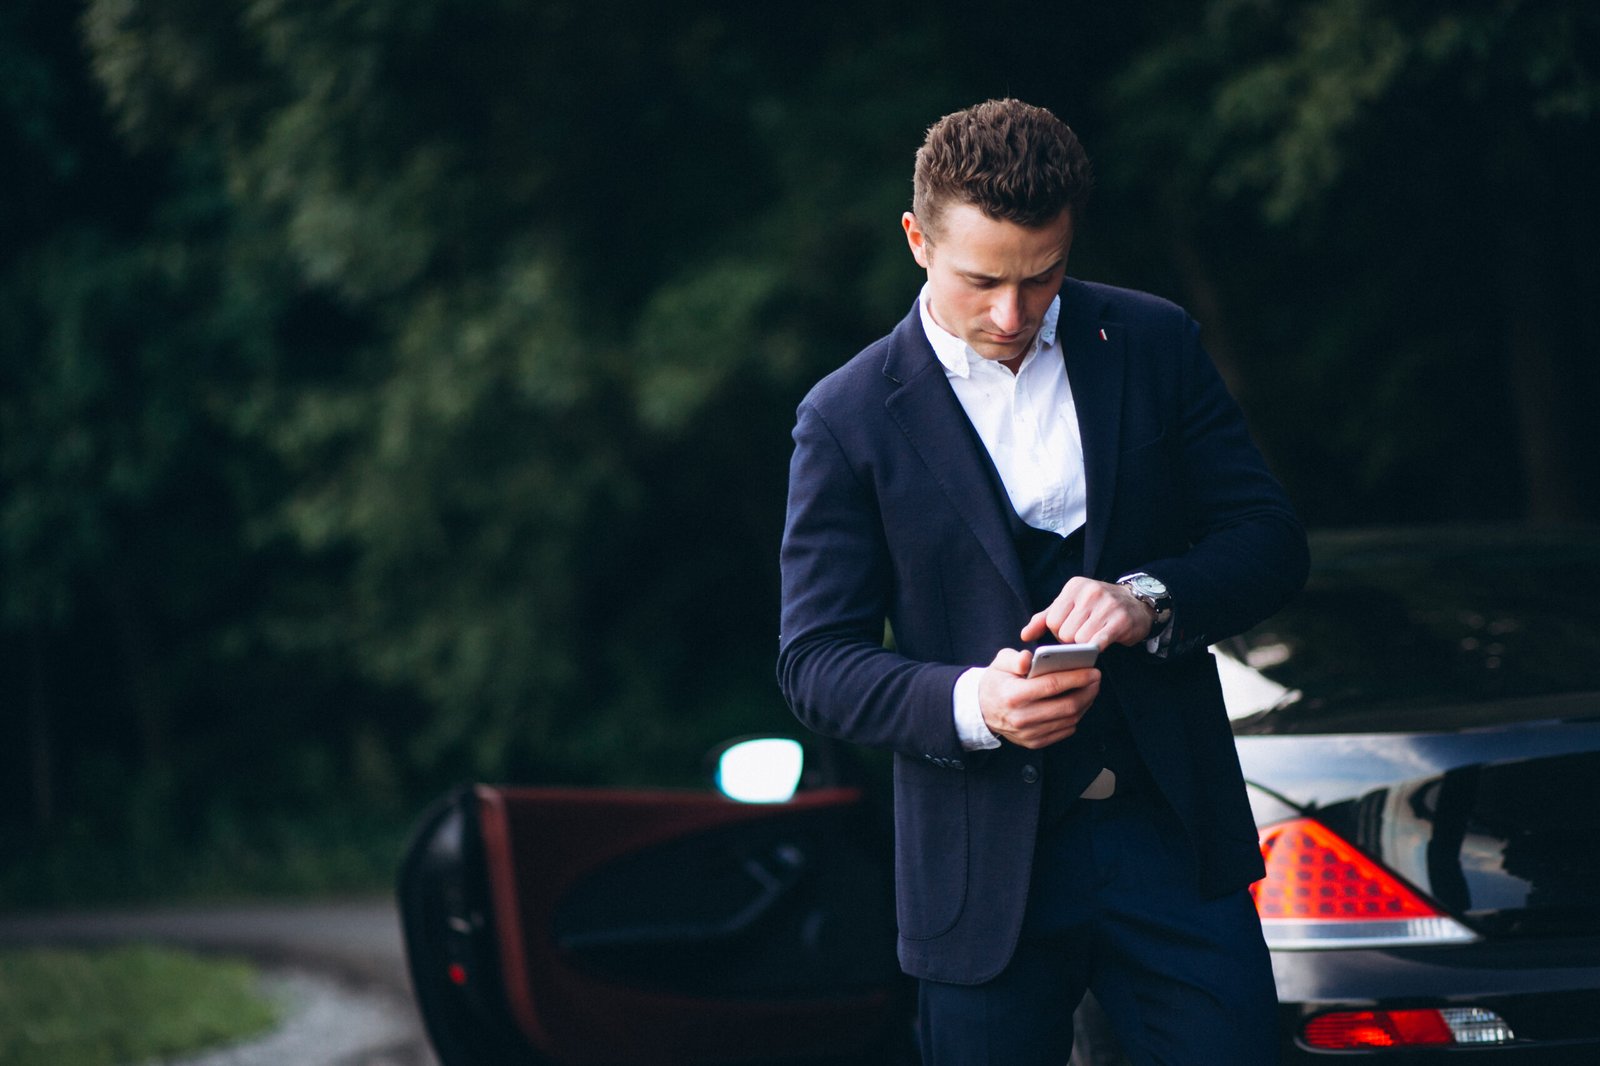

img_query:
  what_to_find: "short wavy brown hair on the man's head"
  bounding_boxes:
[910,99,1094,232]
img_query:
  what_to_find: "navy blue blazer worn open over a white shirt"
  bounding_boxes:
[778,279,1307,983]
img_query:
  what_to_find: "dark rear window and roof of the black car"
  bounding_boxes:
[1218,530,1600,733]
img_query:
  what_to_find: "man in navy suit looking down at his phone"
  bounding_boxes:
[779,101,1307,1066]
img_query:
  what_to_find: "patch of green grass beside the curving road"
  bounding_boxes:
[0,946,278,1066]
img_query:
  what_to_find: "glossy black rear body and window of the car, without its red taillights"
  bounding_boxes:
[1214,528,1600,1066]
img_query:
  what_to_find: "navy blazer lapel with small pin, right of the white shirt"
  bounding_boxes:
[1056,282,1126,576]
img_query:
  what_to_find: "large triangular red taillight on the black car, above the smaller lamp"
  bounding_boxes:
[1250,818,1477,949]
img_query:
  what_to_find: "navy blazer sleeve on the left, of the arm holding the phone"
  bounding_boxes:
[778,402,970,768]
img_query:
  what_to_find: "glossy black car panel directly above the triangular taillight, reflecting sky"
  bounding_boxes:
[1237,720,1600,936]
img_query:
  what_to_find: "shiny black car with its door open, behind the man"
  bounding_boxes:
[400,530,1600,1066]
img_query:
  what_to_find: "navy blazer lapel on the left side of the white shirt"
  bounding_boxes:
[883,306,1029,608]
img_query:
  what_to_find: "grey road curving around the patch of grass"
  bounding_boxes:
[0,900,437,1066]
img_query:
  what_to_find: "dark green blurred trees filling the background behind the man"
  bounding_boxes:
[0,0,1600,901]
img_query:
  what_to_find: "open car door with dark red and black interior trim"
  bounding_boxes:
[402,771,909,1066]
